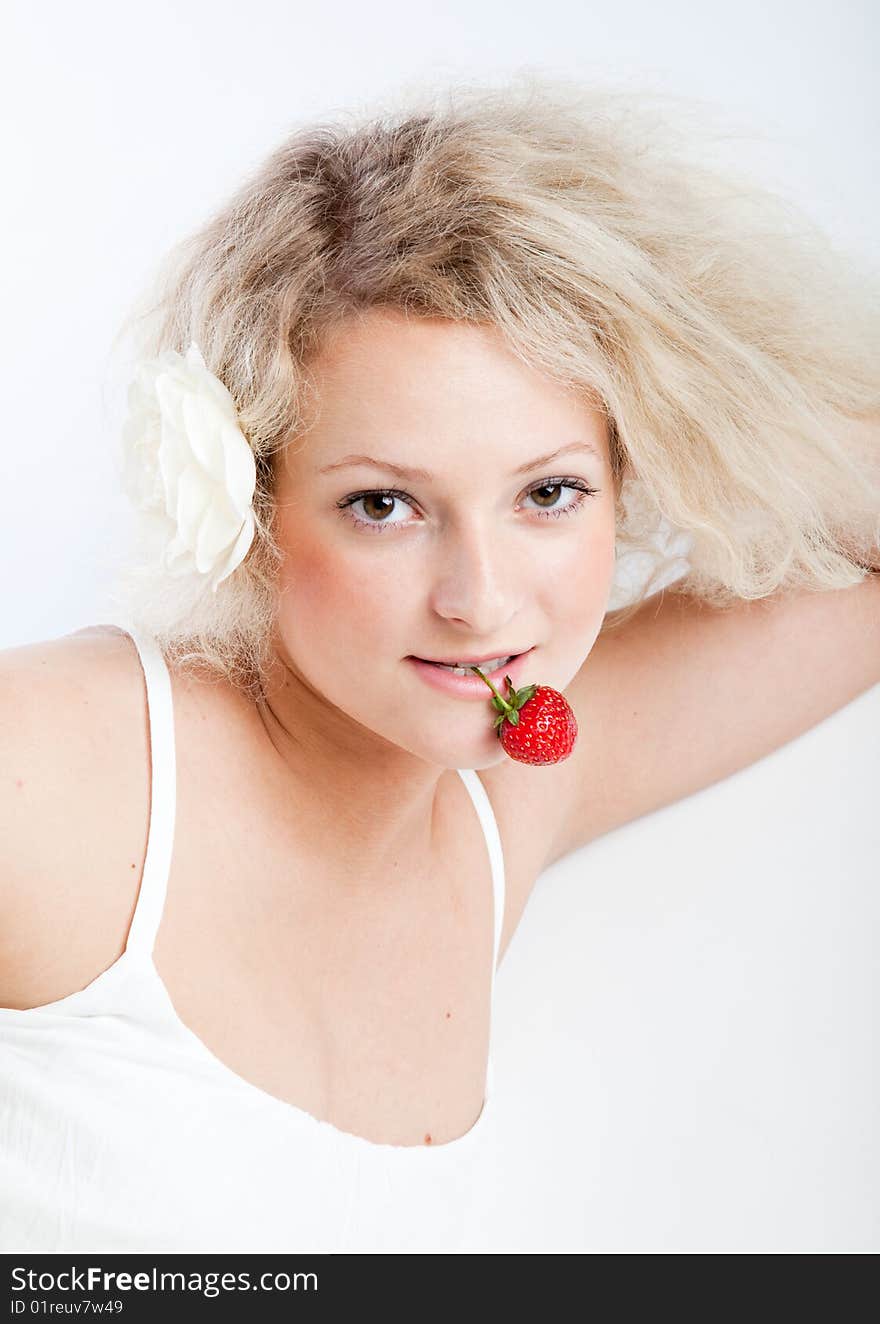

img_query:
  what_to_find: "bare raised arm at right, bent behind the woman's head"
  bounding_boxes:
[548,575,880,863]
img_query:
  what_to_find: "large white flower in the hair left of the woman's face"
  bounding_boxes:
[122,340,257,593]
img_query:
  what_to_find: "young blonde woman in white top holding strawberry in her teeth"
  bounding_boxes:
[0,75,880,1253]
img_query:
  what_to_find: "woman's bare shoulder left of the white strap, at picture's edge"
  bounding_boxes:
[0,626,150,1008]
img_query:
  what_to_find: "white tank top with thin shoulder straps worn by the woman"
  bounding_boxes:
[0,624,504,1254]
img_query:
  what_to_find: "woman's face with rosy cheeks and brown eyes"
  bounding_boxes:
[267,308,615,768]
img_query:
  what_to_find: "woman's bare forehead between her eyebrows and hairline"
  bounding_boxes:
[296,308,607,461]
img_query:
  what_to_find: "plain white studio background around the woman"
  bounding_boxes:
[0,0,880,1250]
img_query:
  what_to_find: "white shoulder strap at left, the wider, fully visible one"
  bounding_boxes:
[124,625,177,956]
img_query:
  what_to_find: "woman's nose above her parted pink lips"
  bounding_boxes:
[430,513,528,646]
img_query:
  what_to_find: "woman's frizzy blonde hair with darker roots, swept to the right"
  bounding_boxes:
[109,74,880,695]
